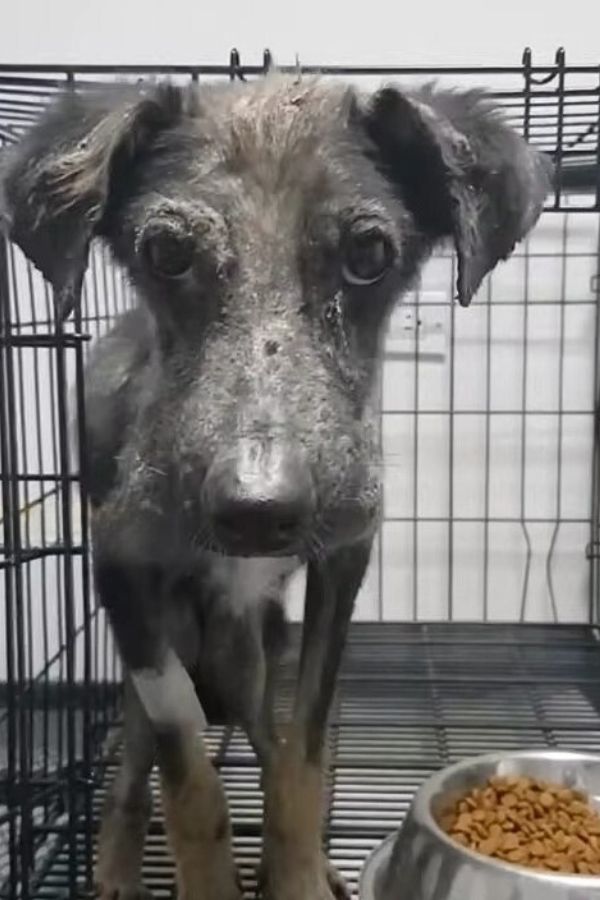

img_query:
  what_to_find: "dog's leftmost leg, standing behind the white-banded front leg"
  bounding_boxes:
[95,677,155,900]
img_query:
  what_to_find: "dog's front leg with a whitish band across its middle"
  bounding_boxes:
[96,565,241,900]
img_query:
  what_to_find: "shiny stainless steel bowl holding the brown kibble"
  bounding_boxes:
[359,751,600,900]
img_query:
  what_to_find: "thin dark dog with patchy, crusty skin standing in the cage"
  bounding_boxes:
[2,75,550,900]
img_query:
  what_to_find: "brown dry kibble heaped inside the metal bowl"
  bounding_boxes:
[440,776,600,875]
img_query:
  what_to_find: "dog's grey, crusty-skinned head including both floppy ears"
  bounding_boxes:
[4,76,549,554]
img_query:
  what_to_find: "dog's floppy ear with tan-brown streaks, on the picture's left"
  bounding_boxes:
[0,85,183,319]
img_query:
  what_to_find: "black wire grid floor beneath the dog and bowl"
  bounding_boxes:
[24,623,600,900]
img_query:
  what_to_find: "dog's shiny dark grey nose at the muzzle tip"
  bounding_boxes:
[204,440,314,556]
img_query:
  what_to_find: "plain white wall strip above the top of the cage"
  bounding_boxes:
[0,0,600,65]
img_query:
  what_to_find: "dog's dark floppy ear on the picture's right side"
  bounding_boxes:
[364,87,552,306]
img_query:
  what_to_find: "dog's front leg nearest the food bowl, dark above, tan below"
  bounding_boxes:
[262,545,370,900]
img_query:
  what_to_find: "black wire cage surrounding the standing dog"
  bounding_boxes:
[0,50,600,900]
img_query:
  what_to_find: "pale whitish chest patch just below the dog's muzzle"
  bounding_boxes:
[204,554,301,615]
